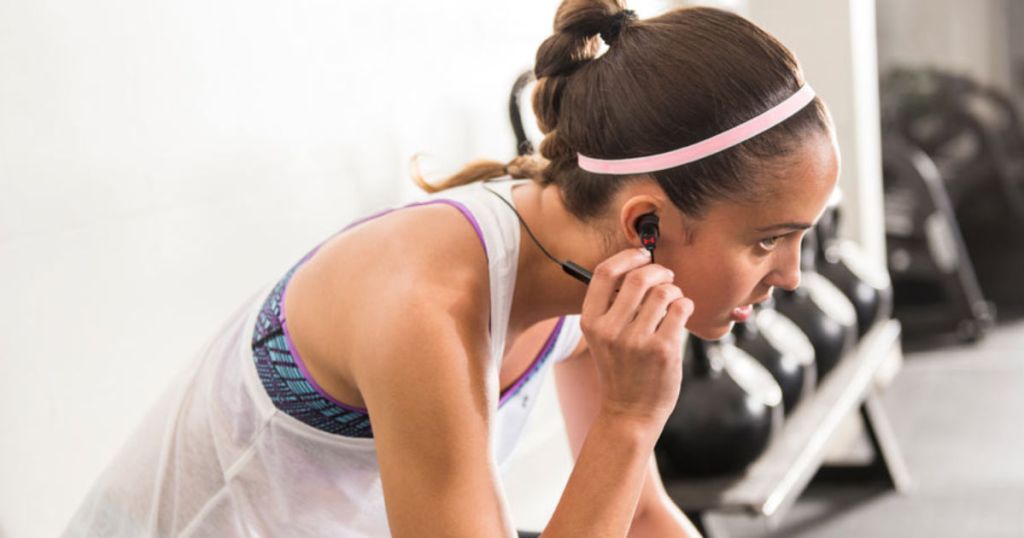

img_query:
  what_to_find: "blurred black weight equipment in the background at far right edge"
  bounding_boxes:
[882,70,1024,316]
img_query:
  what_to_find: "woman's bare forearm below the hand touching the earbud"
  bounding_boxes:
[544,415,656,538]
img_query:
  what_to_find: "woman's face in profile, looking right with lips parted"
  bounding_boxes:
[656,136,839,339]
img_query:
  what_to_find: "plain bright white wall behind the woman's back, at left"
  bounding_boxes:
[0,0,557,538]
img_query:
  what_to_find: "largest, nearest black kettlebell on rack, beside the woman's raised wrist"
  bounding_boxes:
[655,335,782,477]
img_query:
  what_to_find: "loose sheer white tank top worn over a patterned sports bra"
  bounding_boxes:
[65,181,581,538]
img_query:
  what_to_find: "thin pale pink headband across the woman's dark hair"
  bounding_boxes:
[577,84,814,175]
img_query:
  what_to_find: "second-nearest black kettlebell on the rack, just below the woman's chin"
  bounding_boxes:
[732,301,818,415]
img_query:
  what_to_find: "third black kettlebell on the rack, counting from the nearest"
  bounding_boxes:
[774,228,857,383]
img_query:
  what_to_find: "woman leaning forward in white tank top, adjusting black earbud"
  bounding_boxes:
[69,0,838,537]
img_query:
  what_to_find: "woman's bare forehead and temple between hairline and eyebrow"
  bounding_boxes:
[706,136,839,231]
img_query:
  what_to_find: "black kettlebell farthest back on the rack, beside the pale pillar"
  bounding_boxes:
[815,207,893,337]
